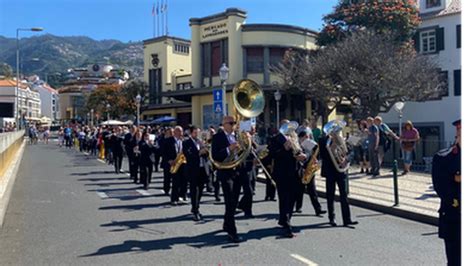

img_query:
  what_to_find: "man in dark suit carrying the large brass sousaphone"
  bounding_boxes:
[211,116,246,243]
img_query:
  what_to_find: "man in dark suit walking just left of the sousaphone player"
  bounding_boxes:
[183,126,208,221]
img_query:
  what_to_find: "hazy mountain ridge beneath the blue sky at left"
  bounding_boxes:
[0,34,143,81]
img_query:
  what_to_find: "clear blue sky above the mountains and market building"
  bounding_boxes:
[0,0,337,42]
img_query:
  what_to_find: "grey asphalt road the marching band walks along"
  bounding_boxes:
[0,143,446,265]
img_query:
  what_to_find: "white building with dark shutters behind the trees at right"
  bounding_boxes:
[382,0,461,149]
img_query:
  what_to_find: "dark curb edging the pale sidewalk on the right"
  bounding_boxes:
[257,176,438,226]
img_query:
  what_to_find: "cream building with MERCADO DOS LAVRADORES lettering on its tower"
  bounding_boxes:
[142,8,317,127]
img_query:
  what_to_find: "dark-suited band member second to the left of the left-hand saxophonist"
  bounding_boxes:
[139,131,155,189]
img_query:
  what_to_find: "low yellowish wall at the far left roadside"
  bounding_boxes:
[0,130,25,178]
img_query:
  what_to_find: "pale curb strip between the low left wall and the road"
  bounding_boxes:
[0,139,26,228]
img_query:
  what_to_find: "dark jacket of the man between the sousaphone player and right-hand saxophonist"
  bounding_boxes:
[268,133,298,181]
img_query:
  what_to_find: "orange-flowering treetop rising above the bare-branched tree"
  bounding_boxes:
[318,0,421,46]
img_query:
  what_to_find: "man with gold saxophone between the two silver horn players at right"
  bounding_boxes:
[296,131,326,216]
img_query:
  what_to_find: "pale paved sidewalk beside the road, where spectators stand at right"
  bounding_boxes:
[258,167,440,225]
